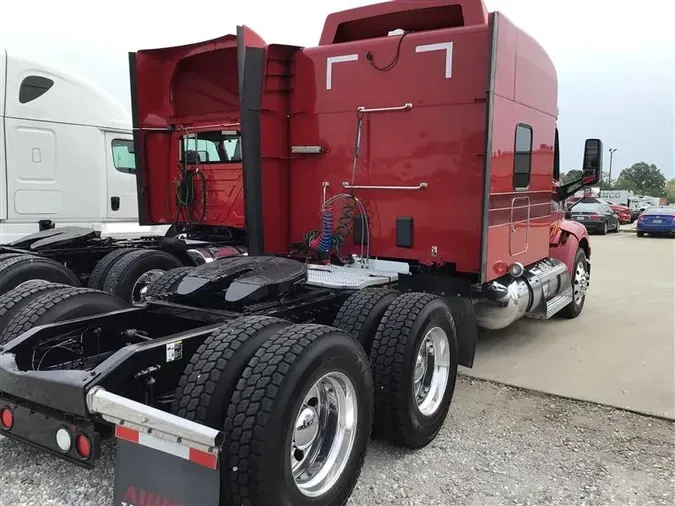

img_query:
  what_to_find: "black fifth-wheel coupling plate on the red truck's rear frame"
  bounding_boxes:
[176,256,307,302]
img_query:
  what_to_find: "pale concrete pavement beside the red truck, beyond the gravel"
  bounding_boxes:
[464,233,675,419]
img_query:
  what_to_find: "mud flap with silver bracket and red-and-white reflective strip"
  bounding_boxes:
[87,387,223,506]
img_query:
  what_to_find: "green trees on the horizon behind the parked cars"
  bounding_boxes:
[562,162,675,204]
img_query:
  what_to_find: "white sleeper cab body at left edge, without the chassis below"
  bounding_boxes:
[0,50,169,244]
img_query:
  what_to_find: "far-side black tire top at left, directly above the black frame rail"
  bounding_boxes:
[0,287,129,343]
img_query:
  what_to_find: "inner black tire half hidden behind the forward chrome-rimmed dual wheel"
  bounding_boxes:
[333,288,400,353]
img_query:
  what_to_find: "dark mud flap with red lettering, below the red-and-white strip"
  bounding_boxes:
[113,439,220,506]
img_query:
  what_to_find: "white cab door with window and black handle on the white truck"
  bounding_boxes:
[105,132,138,221]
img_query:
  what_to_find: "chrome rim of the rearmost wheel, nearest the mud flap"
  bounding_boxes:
[290,372,358,497]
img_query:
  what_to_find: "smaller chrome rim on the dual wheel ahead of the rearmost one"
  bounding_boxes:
[413,327,450,416]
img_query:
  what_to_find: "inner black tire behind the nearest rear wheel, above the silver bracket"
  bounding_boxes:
[173,316,290,430]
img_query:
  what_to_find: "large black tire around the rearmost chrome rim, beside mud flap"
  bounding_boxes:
[227,324,373,506]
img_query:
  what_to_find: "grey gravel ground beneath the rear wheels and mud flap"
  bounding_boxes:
[0,377,675,506]
